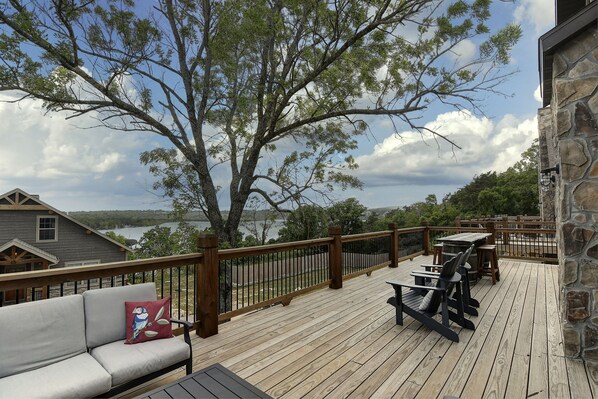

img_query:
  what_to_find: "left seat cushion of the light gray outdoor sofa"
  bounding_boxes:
[0,354,111,399]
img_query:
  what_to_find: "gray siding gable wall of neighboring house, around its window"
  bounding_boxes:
[0,210,126,268]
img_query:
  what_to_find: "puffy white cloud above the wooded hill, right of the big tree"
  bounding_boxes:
[355,111,537,188]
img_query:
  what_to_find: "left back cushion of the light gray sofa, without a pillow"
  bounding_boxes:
[0,295,87,378]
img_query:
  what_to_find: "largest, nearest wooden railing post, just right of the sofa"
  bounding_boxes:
[195,233,218,338]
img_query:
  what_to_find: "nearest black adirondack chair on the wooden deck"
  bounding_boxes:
[387,253,475,342]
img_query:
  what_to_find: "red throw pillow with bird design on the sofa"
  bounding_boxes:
[125,297,173,344]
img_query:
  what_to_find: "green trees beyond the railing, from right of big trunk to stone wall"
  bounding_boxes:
[279,140,539,242]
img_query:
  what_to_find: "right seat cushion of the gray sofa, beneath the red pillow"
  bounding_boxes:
[91,337,190,386]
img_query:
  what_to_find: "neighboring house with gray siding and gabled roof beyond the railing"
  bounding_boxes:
[0,188,130,306]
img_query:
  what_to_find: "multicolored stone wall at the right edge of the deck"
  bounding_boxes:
[539,26,598,361]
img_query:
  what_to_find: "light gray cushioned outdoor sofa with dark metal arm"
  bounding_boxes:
[0,283,192,399]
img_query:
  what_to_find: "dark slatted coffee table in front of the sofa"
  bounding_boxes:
[138,364,272,399]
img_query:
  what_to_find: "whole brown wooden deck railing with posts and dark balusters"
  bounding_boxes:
[0,223,556,337]
